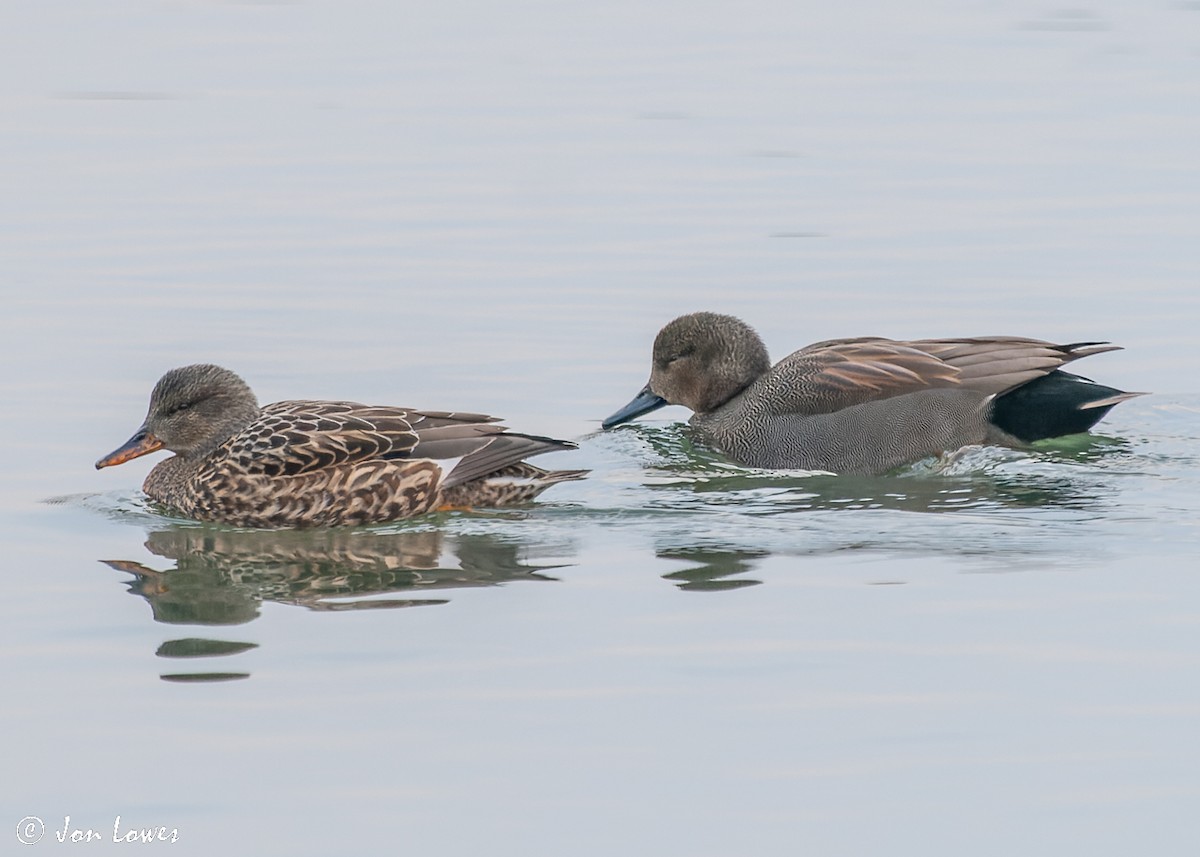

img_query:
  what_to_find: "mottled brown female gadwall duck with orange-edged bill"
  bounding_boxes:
[96,364,587,528]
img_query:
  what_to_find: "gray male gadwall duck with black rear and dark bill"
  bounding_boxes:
[604,312,1142,474]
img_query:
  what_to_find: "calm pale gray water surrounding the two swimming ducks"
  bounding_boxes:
[0,0,1200,857]
